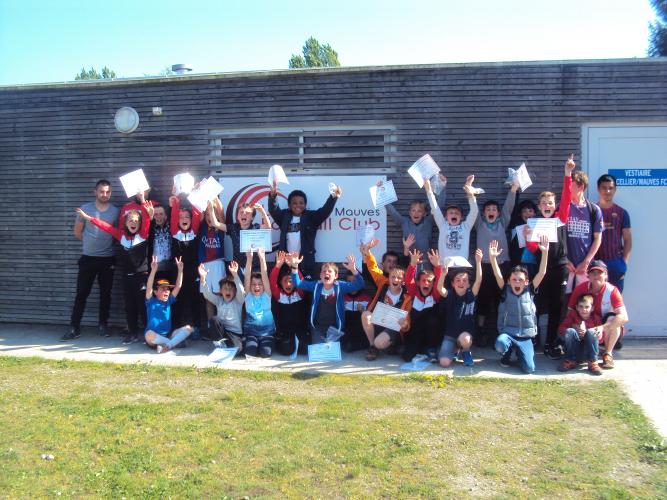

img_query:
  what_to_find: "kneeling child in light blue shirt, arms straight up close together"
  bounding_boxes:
[243,248,276,358]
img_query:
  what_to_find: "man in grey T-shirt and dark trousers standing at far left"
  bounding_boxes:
[60,179,119,342]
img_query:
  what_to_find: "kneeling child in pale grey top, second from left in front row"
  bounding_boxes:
[199,260,245,353]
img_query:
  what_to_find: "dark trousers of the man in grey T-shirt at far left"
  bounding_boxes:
[70,255,116,328]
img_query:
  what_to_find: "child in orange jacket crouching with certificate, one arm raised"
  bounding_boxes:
[360,241,412,361]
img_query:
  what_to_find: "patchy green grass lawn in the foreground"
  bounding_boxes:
[0,357,667,498]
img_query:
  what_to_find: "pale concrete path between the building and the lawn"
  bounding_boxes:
[0,323,667,437]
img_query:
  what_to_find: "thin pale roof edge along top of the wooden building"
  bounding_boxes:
[0,57,667,91]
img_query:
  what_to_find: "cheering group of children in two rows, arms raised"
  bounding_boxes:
[78,154,628,374]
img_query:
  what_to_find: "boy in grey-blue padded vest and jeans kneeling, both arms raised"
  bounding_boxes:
[489,235,549,373]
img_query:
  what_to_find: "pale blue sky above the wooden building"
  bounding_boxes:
[0,0,654,85]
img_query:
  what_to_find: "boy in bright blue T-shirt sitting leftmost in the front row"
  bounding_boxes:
[144,257,192,354]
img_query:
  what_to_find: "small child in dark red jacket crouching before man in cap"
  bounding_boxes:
[558,294,604,375]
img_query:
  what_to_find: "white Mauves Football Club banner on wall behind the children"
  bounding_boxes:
[217,175,387,267]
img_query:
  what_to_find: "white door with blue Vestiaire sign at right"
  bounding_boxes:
[582,123,667,336]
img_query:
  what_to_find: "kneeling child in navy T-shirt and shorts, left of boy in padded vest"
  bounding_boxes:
[437,248,483,368]
